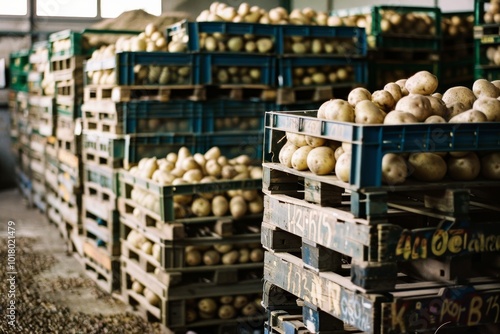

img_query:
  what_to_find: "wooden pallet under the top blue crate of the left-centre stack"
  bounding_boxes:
[83,85,206,102]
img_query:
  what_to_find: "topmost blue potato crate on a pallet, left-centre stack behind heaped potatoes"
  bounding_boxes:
[85,52,200,85]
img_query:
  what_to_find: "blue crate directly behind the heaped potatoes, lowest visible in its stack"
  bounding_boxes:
[195,131,264,162]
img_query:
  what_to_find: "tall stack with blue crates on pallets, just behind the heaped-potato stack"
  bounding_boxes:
[82,48,199,292]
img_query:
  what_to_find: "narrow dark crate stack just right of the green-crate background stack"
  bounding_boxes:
[439,12,474,93]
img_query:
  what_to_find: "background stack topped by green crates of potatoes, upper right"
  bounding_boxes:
[331,5,441,91]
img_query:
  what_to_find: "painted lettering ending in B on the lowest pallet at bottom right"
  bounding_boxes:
[383,288,500,333]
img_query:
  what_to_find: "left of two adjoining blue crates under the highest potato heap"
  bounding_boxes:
[166,21,279,54]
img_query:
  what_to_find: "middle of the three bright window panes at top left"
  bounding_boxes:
[36,0,97,17]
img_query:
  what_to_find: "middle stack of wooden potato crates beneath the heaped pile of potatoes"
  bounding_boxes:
[119,170,264,333]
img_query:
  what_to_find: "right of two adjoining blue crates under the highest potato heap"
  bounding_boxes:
[277,25,367,58]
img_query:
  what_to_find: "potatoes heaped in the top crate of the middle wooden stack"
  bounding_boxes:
[130,147,264,219]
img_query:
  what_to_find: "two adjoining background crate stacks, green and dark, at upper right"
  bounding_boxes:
[331,5,474,91]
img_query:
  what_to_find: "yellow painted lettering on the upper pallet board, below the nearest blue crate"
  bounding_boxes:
[396,229,500,260]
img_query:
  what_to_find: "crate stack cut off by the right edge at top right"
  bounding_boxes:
[474,0,500,81]
